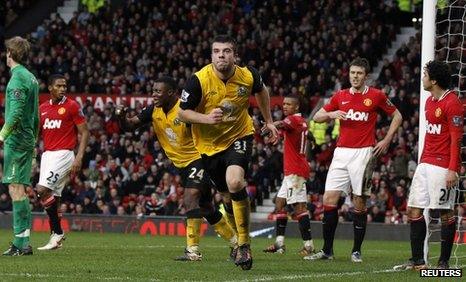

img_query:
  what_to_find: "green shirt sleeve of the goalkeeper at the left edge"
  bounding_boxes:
[0,76,27,141]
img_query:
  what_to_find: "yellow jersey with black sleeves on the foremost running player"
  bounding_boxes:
[181,64,263,156]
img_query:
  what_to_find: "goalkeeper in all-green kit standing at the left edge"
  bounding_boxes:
[0,36,39,256]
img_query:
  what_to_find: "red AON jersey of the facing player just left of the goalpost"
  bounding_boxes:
[324,86,396,148]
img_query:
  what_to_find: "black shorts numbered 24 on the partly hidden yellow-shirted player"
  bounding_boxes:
[179,159,213,202]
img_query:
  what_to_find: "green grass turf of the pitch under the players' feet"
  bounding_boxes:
[0,230,466,281]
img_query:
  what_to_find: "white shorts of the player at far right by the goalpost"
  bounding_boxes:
[408,163,457,210]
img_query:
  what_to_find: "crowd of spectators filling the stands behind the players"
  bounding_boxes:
[0,0,466,224]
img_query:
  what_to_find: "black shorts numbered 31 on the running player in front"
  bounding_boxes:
[202,135,253,192]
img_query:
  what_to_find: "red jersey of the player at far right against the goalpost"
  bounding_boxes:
[421,91,464,172]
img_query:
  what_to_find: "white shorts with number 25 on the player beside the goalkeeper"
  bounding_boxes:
[38,150,74,197]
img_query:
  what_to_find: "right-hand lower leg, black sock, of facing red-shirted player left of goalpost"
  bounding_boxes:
[351,195,367,262]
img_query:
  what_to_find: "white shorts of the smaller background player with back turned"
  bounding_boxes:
[277,174,307,205]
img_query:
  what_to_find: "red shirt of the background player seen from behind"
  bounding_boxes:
[283,114,309,179]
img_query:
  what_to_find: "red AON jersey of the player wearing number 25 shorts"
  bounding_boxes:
[39,97,86,151]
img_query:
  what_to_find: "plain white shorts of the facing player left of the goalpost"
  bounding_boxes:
[325,147,373,196]
